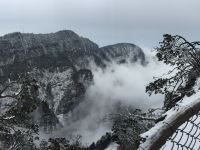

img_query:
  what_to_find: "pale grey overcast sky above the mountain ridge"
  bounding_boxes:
[0,0,200,48]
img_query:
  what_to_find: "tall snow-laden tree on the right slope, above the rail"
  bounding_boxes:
[146,34,200,110]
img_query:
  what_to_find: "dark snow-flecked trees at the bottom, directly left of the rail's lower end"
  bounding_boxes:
[111,108,156,150]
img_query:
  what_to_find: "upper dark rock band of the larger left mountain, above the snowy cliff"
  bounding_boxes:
[0,30,98,79]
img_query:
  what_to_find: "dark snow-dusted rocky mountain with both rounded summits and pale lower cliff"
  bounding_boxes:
[0,30,145,130]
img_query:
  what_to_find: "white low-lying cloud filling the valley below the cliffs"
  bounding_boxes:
[51,51,169,144]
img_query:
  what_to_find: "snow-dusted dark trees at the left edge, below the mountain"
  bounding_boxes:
[0,78,38,150]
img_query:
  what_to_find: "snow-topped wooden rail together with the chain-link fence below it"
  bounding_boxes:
[139,99,200,150]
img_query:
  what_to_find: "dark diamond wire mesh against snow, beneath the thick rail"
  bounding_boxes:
[161,113,200,150]
